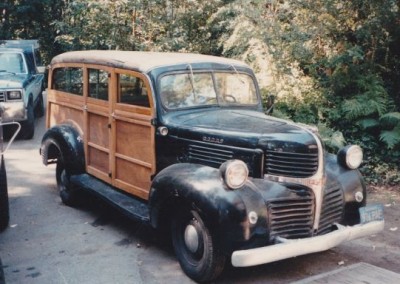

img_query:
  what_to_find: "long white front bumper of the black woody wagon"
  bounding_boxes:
[231,220,385,267]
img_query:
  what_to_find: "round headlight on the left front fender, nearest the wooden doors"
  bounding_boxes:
[220,160,249,189]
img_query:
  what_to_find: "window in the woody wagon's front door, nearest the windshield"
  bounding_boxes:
[118,74,150,107]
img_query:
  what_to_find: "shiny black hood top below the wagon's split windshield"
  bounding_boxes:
[165,109,317,152]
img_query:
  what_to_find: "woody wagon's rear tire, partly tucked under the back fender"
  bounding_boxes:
[56,156,79,207]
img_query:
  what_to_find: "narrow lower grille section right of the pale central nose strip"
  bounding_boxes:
[318,184,343,235]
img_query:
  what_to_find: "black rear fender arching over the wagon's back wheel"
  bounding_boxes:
[40,122,85,175]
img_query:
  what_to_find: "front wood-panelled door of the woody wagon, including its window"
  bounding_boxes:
[111,69,155,200]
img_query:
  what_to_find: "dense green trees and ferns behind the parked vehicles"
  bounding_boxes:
[0,0,400,181]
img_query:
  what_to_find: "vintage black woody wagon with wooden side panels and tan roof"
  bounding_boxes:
[40,51,384,282]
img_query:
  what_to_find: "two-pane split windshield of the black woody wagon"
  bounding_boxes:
[159,71,258,109]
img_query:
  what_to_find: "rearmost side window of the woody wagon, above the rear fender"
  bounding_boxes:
[52,67,83,96]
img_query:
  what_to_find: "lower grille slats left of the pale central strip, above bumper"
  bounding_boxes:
[267,188,314,241]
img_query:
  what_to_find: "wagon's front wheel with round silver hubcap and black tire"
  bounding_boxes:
[171,206,226,282]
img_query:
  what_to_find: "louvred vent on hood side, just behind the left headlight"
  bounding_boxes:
[188,144,233,167]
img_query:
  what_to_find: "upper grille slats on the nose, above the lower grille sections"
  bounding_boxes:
[265,150,318,178]
